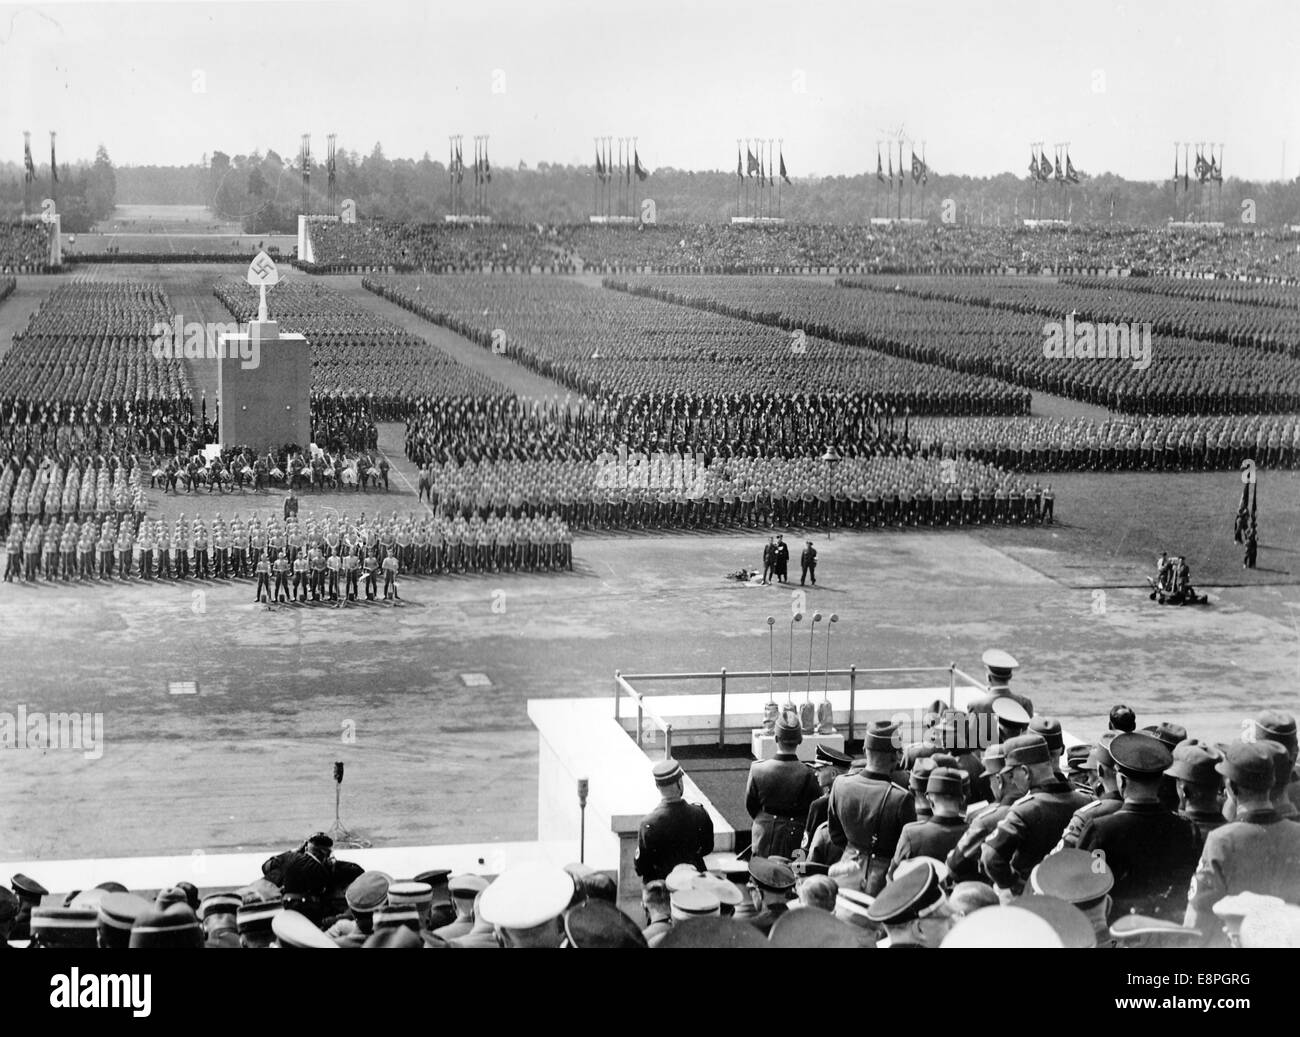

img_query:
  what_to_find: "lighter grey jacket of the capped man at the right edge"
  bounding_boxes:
[1186,810,1300,933]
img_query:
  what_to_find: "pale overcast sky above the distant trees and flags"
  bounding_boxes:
[0,0,1300,179]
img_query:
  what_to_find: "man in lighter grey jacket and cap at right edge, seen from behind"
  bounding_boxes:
[1184,741,1300,942]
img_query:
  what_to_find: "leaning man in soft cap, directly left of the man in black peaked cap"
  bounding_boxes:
[980,734,1088,903]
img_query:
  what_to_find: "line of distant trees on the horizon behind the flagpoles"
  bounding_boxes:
[0,144,1300,233]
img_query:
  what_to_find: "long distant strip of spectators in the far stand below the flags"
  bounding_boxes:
[299,221,1300,279]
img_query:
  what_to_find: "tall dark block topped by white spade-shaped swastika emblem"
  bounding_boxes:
[217,252,312,454]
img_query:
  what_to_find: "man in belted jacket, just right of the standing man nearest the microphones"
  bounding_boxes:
[827,720,917,897]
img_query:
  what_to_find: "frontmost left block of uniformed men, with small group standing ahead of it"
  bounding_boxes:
[4,506,573,589]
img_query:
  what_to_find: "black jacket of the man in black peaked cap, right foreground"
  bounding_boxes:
[1079,802,1197,921]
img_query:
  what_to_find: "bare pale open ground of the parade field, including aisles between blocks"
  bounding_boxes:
[0,264,1300,858]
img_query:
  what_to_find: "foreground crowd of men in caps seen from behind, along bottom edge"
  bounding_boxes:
[0,696,1300,950]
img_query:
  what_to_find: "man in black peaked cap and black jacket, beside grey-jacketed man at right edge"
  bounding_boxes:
[1079,733,1197,921]
